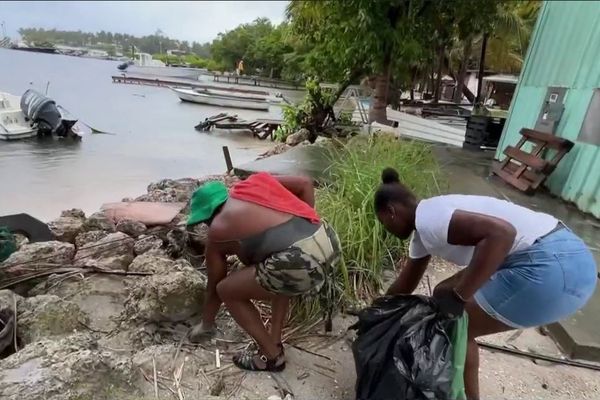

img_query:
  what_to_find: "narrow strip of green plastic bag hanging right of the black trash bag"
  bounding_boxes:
[450,313,469,400]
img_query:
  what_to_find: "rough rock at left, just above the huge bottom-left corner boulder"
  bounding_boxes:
[17,295,89,344]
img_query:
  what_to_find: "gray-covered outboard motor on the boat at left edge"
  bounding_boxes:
[21,89,62,136]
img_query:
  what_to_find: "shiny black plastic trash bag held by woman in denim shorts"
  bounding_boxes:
[352,295,454,400]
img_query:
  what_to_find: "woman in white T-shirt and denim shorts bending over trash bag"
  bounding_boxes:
[375,168,597,400]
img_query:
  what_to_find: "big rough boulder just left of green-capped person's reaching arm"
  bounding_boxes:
[125,266,206,322]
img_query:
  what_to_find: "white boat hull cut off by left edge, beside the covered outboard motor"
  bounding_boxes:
[0,92,38,140]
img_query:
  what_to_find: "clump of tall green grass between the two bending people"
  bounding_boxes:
[293,135,441,320]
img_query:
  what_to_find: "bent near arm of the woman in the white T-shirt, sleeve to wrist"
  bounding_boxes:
[448,210,517,300]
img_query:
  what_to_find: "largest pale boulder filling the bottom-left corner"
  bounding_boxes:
[0,334,139,400]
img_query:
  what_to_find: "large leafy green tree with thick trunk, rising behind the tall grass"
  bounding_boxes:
[288,0,435,123]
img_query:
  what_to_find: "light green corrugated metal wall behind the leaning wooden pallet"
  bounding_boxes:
[496,1,600,218]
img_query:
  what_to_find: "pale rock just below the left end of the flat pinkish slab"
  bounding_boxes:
[75,232,134,270]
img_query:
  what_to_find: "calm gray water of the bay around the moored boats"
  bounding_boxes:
[0,49,290,220]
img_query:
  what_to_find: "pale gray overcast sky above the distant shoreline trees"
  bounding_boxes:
[0,1,288,42]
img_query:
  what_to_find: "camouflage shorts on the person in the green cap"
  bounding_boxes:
[256,222,341,296]
